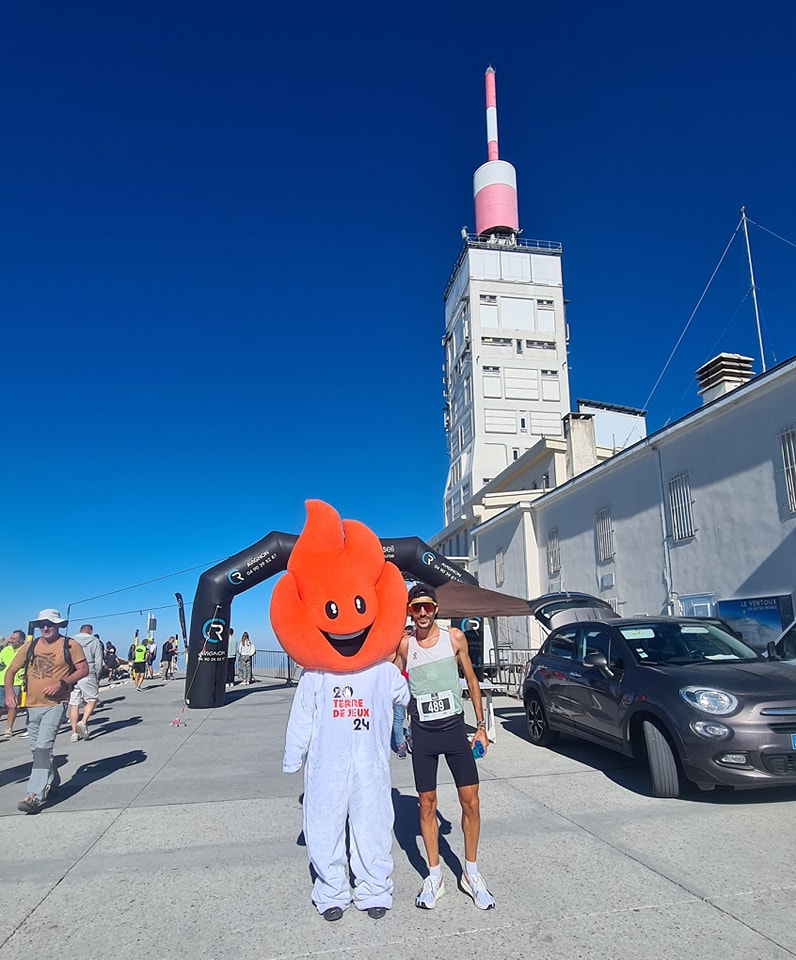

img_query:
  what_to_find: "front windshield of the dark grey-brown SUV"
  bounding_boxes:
[618,620,761,664]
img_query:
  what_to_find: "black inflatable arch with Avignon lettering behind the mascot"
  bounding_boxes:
[185,531,477,710]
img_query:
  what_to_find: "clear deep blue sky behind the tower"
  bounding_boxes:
[0,0,796,647]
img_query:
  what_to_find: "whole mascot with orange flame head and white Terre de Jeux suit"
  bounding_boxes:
[271,500,409,920]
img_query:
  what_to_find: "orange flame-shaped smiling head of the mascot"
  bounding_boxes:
[271,500,406,673]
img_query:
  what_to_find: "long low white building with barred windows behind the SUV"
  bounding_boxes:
[448,356,796,647]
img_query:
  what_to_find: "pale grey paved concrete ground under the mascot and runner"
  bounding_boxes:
[0,668,796,960]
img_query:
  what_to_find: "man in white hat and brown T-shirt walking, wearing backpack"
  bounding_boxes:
[4,608,88,814]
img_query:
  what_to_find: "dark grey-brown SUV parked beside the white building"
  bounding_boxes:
[523,616,796,797]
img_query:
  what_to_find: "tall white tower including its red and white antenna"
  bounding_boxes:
[442,67,569,536]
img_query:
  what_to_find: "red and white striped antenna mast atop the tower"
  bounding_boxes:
[473,67,520,237]
